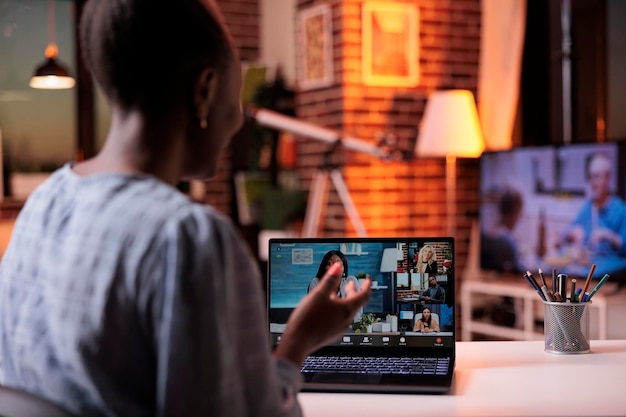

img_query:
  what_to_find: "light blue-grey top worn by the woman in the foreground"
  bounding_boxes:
[0,164,302,417]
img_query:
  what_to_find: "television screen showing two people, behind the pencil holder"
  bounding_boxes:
[479,142,626,280]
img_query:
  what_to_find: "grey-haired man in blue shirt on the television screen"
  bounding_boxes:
[564,153,626,270]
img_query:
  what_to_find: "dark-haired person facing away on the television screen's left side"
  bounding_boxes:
[480,187,524,272]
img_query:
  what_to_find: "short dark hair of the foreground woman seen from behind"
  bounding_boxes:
[80,0,232,116]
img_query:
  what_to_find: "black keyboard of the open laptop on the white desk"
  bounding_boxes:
[301,356,450,375]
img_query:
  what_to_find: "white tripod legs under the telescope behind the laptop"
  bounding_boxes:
[302,145,367,237]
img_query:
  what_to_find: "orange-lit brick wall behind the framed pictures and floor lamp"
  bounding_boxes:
[297,0,480,271]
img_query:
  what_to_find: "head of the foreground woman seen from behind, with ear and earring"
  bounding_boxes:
[80,0,242,177]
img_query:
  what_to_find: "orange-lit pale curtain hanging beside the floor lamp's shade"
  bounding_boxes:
[477,0,526,150]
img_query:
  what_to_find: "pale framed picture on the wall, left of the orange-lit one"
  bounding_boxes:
[297,4,334,90]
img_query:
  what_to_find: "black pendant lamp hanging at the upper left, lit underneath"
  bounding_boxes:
[30,0,76,90]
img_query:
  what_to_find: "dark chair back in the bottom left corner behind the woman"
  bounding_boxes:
[0,386,76,417]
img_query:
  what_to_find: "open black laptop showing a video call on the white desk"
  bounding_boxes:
[267,237,456,393]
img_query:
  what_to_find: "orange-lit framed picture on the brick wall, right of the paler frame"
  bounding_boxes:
[361,2,419,87]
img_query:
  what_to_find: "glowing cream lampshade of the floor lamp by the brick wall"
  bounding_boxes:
[415,90,485,158]
